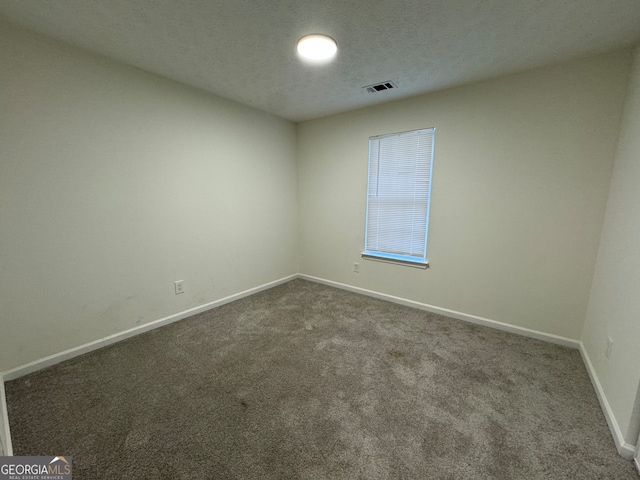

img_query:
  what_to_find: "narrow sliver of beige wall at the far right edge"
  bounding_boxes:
[583,49,640,445]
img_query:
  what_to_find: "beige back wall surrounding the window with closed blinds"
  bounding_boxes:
[298,52,631,339]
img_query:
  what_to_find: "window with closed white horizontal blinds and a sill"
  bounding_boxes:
[362,128,436,268]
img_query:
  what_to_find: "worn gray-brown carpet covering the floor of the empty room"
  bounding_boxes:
[6,280,637,480]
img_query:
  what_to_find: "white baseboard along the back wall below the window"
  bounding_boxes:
[298,274,580,350]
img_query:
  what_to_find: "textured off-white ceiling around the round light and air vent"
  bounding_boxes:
[0,0,640,121]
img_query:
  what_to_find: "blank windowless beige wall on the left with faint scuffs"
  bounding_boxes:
[0,25,298,371]
